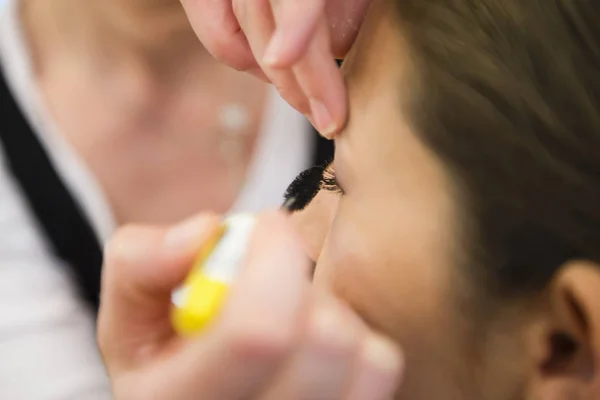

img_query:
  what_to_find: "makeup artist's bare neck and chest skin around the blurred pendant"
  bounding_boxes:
[21,0,267,224]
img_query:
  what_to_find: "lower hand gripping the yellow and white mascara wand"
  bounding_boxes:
[98,203,401,400]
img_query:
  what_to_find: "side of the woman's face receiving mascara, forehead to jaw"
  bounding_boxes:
[297,3,528,400]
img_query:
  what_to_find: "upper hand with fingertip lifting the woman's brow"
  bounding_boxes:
[181,0,373,137]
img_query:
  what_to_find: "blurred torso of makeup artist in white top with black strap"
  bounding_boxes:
[0,0,332,400]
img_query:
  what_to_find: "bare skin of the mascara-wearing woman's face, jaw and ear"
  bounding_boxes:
[298,2,600,400]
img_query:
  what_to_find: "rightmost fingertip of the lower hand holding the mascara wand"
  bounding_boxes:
[344,334,403,400]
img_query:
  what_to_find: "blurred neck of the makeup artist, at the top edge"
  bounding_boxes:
[22,0,208,74]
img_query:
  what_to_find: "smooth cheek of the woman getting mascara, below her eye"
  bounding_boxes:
[314,200,448,340]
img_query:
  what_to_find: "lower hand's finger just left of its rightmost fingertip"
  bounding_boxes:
[261,301,366,400]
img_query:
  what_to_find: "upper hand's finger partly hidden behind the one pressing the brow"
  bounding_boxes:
[234,0,310,114]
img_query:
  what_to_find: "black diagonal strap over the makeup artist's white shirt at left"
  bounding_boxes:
[0,68,102,311]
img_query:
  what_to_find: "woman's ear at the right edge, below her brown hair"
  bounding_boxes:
[535,261,600,400]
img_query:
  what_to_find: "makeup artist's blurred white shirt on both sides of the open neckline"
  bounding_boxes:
[0,0,313,400]
